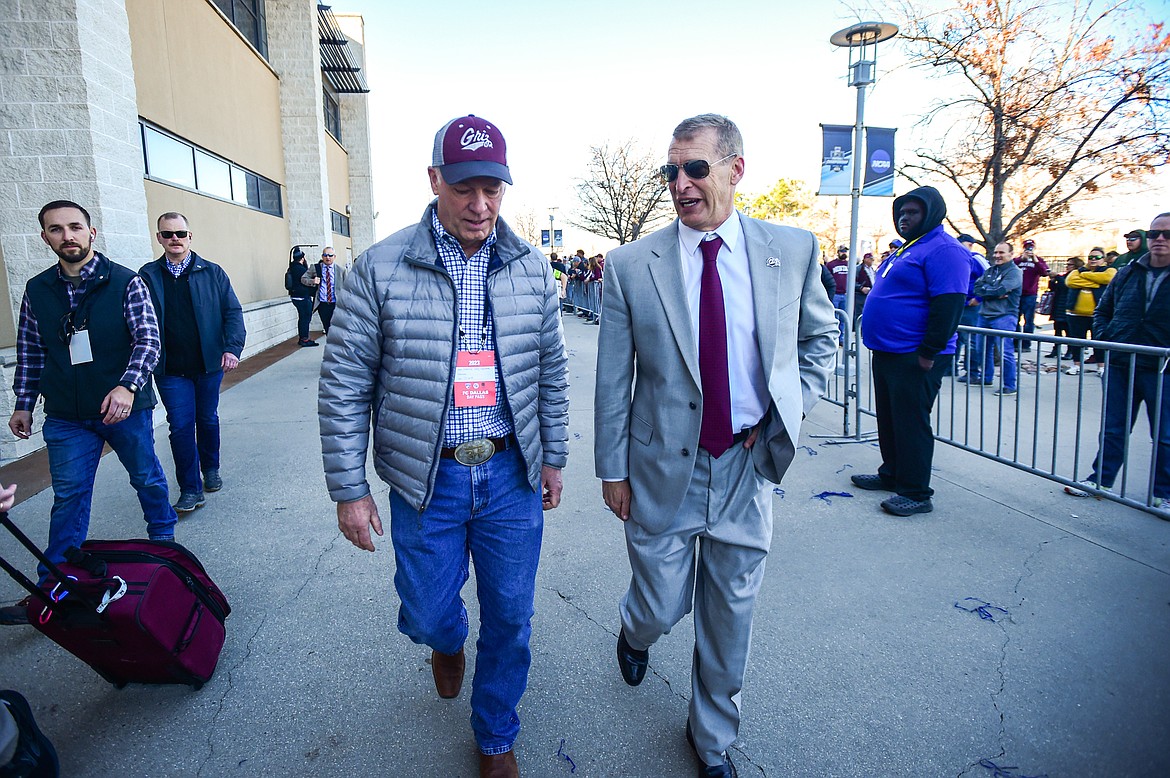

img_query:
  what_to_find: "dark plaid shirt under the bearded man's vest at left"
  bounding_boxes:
[12,252,161,411]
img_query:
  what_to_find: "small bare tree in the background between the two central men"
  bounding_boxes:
[569,139,670,243]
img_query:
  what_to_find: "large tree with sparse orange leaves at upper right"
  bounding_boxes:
[900,0,1170,246]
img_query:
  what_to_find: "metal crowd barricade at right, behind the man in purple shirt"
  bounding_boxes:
[825,326,1170,518]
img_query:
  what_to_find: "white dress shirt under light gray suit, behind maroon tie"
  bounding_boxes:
[679,211,770,432]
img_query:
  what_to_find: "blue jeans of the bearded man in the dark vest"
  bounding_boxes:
[37,408,177,583]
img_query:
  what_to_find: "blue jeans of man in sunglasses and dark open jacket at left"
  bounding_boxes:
[154,370,223,493]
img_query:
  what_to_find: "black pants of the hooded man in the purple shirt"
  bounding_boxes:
[873,351,951,500]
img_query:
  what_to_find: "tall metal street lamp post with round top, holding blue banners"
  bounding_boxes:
[828,21,897,436]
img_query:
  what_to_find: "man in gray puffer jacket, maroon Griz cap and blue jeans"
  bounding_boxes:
[319,116,569,776]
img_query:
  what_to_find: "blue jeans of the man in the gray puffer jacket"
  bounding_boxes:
[390,446,544,755]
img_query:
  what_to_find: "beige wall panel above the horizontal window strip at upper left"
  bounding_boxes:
[126,0,284,184]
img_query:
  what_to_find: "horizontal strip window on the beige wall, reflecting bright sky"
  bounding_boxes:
[138,122,284,218]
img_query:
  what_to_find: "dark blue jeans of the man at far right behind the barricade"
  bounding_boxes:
[1089,363,1170,497]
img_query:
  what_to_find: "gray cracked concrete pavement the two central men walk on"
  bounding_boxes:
[0,317,1170,778]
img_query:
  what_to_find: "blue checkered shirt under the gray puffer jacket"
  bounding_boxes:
[431,211,514,447]
